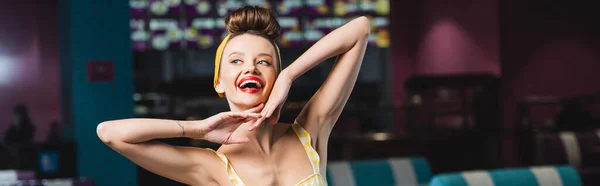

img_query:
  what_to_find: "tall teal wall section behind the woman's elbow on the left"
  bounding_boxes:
[58,0,137,186]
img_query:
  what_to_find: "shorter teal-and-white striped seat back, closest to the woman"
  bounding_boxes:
[327,158,431,186]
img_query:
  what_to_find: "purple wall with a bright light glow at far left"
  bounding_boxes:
[0,0,61,141]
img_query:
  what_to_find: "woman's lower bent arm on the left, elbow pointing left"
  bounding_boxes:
[97,119,219,185]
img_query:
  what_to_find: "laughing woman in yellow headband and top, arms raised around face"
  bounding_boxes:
[97,7,370,186]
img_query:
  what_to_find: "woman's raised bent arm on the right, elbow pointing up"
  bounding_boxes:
[281,16,370,137]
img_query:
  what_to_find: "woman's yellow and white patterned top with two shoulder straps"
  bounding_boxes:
[211,122,327,186]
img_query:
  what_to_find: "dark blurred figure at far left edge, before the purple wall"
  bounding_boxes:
[4,104,35,144]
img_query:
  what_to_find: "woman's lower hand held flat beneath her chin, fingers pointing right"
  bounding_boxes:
[197,104,264,144]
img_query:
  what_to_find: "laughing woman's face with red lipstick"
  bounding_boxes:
[217,34,279,108]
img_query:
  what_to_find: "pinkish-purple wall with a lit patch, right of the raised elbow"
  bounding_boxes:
[390,0,500,130]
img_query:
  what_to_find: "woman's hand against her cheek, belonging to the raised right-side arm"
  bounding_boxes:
[248,70,293,130]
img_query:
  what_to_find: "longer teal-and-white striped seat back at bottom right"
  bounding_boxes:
[430,166,582,186]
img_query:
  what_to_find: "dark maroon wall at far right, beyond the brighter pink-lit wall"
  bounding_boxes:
[500,0,600,164]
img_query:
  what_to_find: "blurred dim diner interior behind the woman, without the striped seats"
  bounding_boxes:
[0,0,600,185]
